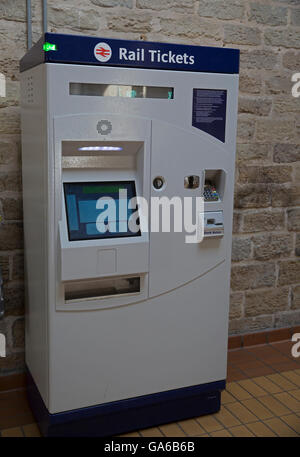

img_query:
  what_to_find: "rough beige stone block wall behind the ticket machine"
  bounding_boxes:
[0,0,300,375]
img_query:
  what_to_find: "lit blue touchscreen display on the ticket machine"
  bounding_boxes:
[64,181,141,241]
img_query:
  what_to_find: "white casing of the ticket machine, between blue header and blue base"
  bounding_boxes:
[21,56,238,414]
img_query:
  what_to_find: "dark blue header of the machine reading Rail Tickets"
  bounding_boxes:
[20,33,239,74]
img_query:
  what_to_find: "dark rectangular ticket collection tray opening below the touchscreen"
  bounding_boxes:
[64,277,141,303]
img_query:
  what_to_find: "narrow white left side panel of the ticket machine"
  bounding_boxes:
[21,65,48,404]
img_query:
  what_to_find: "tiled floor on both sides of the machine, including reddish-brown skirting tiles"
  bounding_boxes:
[0,342,300,437]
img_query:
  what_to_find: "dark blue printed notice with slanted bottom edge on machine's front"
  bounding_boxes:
[192,89,227,143]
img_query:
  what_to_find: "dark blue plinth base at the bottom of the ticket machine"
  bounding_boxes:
[27,370,226,437]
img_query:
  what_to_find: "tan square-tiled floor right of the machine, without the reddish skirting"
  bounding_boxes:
[123,369,300,437]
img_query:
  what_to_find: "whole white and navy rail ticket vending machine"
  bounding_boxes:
[21,33,239,436]
